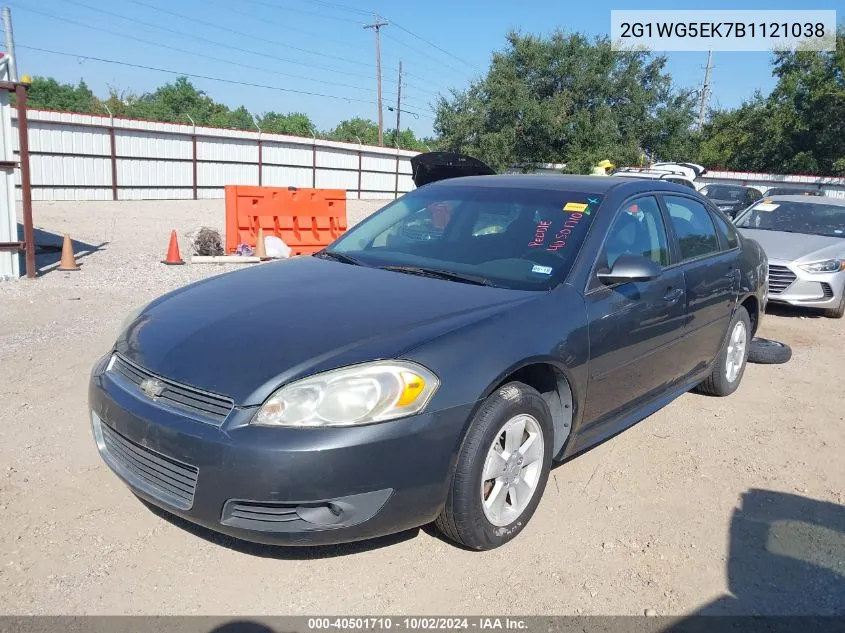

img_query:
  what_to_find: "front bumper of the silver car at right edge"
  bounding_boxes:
[768,260,845,308]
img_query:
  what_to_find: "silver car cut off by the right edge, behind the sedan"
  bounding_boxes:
[734,195,845,319]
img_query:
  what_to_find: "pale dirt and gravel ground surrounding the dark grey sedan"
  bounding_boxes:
[0,200,845,615]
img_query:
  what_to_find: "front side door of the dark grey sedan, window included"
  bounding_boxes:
[583,195,686,429]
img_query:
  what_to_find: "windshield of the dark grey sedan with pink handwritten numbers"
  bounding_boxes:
[326,184,603,290]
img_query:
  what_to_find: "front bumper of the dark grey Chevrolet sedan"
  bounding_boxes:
[89,358,471,545]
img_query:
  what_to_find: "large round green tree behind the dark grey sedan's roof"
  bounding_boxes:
[435,31,694,173]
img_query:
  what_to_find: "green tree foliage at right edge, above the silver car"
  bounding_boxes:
[699,26,845,176]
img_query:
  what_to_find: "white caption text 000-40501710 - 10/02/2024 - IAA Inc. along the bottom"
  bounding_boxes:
[308,617,528,631]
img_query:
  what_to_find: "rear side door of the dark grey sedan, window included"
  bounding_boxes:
[662,194,741,375]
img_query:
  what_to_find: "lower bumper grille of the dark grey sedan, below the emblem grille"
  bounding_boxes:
[95,419,199,510]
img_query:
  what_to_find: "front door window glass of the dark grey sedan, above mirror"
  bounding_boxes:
[601,196,669,268]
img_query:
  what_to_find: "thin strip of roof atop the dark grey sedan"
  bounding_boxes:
[425,174,690,193]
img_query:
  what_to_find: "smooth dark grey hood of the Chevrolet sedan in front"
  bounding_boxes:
[115,257,543,405]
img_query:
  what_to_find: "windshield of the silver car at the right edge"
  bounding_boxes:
[735,201,845,237]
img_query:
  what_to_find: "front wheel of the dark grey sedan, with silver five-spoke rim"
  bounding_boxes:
[435,382,554,551]
